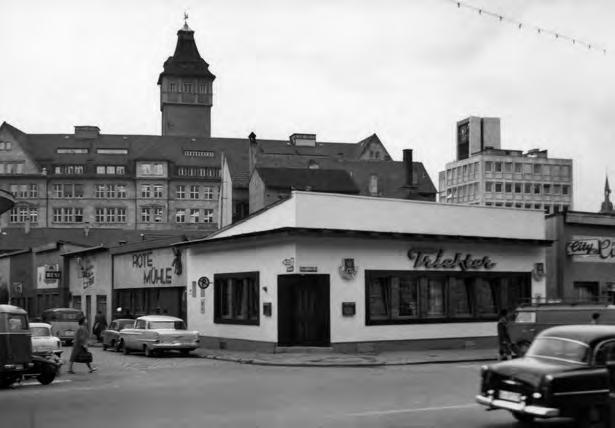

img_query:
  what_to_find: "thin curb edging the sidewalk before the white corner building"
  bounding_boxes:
[201,354,496,367]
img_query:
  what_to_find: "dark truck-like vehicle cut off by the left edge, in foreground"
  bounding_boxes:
[0,305,60,388]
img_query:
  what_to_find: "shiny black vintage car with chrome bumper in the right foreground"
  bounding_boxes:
[476,325,615,426]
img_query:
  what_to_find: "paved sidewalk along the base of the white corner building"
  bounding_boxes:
[194,348,498,367]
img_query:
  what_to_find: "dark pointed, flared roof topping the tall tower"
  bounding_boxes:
[158,25,216,85]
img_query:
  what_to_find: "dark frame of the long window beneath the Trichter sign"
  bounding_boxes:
[364,270,532,326]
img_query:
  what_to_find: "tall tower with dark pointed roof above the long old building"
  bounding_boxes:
[158,16,216,137]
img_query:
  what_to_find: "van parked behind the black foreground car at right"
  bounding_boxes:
[508,303,615,356]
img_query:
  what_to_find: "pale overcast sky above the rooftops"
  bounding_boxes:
[0,0,615,211]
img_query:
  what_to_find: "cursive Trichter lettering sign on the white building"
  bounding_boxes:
[408,248,496,272]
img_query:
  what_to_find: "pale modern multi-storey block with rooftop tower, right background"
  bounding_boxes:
[439,117,573,214]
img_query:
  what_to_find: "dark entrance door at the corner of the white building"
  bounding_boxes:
[278,275,331,346]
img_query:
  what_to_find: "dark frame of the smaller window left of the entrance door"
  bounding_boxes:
[214,271,260,325]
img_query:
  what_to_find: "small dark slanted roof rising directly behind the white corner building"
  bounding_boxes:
[256,167,359,194]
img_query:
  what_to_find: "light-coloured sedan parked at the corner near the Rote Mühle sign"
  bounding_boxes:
[119,315,199,357]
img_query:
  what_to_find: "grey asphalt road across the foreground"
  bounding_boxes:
[0,348,573,428]
